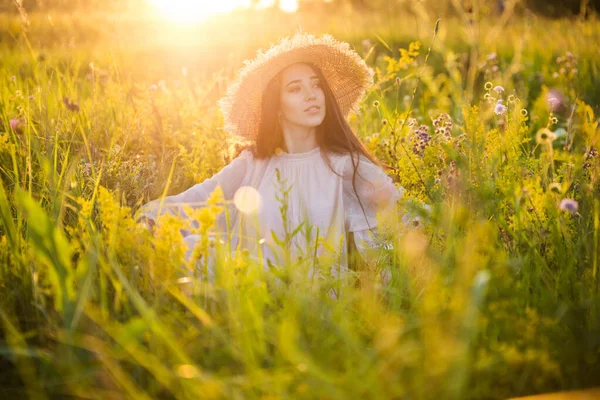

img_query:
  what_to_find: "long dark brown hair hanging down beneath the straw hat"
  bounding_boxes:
[236,63,384,247]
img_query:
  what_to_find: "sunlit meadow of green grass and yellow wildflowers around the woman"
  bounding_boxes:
[0,3,600,399]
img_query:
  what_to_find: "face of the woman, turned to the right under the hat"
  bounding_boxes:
[280,63,326,127]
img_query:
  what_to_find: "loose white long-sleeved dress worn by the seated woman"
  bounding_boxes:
[139,147,402,275]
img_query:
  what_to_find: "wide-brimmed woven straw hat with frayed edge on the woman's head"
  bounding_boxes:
[218,33,373,139]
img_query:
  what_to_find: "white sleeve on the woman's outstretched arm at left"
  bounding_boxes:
[136,150,253,231]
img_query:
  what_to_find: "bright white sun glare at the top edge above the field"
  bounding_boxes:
[148,0,298,22]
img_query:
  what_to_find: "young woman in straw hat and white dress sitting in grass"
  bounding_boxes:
[140,34,401,282]
